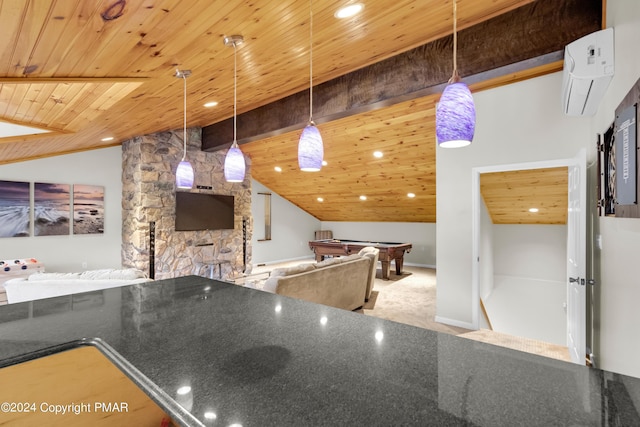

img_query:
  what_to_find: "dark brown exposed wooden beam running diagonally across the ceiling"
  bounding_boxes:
[202,0,602,151]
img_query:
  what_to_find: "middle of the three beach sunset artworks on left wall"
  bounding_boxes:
[33,182,71,236]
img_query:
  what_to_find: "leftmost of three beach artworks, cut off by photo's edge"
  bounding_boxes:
[0,181,31,237]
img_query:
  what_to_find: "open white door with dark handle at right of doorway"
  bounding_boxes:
[567,150,587,365]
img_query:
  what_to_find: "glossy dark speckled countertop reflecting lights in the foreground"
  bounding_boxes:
[0,276,640,427]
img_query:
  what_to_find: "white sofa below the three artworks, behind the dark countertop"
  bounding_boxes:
[4,268,152,304]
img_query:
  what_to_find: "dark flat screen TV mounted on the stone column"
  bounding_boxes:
[176,191,235,231]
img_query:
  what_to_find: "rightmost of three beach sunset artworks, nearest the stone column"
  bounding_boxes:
[73,184,104,234]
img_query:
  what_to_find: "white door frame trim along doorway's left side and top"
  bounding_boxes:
[471,158,576,330]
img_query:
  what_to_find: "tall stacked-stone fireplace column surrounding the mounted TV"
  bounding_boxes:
[122,128,253,280]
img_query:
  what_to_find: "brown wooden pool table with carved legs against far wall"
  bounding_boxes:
[309,239,411,280]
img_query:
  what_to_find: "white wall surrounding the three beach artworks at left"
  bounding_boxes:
[0,147,122,272]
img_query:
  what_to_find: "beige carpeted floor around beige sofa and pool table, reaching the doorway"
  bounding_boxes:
[253,261,570,361]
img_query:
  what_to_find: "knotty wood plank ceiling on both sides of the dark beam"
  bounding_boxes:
[0,0,603,222]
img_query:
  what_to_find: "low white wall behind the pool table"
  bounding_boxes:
[322,221,436,268]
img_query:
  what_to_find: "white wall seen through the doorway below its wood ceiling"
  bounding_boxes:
[486,224,567,345]
